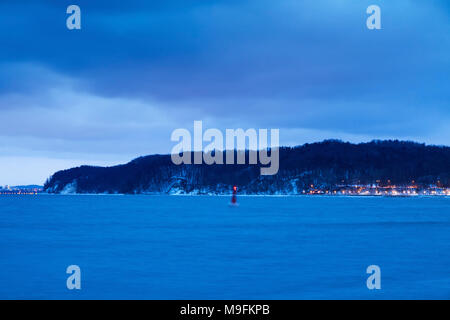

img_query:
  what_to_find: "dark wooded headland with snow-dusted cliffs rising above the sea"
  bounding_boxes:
[44,140,450,194]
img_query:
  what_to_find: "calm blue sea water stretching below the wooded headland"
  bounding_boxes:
[0,195,450,299]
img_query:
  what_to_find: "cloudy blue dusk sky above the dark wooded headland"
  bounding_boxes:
[0,0,450,185]
